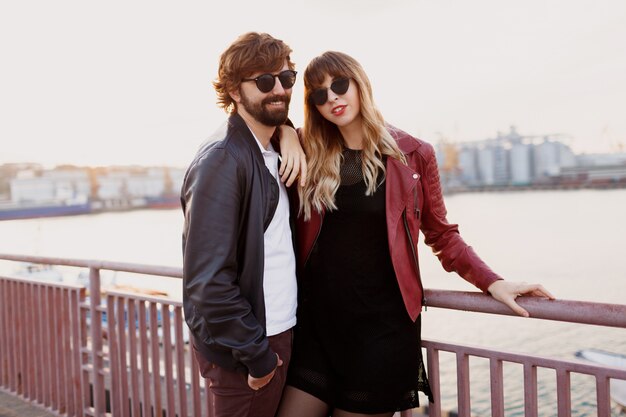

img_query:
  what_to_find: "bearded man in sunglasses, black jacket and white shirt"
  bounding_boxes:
[181,33,297,417]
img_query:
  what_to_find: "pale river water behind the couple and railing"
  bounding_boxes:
[0,190,626,417]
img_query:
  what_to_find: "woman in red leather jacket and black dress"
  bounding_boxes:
[278,52,553,417]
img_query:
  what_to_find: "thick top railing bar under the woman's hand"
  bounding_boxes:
[425,290,626,328]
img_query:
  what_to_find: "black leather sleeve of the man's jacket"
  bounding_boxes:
[183,148,277,377]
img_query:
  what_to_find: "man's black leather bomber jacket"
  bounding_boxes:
[181,114,279,377]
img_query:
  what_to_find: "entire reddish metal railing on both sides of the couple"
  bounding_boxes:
[0,254,626,417]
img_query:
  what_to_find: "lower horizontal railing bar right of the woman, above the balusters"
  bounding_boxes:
[422,340,626,379]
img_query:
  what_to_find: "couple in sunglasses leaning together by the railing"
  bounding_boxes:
[181,33,552,417]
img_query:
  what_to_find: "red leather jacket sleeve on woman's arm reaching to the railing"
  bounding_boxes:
[414,144,502,292]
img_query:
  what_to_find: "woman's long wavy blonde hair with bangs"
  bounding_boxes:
[298,51,406,220]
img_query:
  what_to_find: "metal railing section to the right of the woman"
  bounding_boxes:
[422,290,626,417]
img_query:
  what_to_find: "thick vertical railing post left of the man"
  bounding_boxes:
[89,267,106,417]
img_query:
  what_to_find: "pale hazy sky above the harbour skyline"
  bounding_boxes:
[0,0,626,167]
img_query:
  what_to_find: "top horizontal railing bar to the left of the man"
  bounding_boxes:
[0,253,183,278]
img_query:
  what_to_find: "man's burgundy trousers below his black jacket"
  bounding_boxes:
[194,329,292,417]
